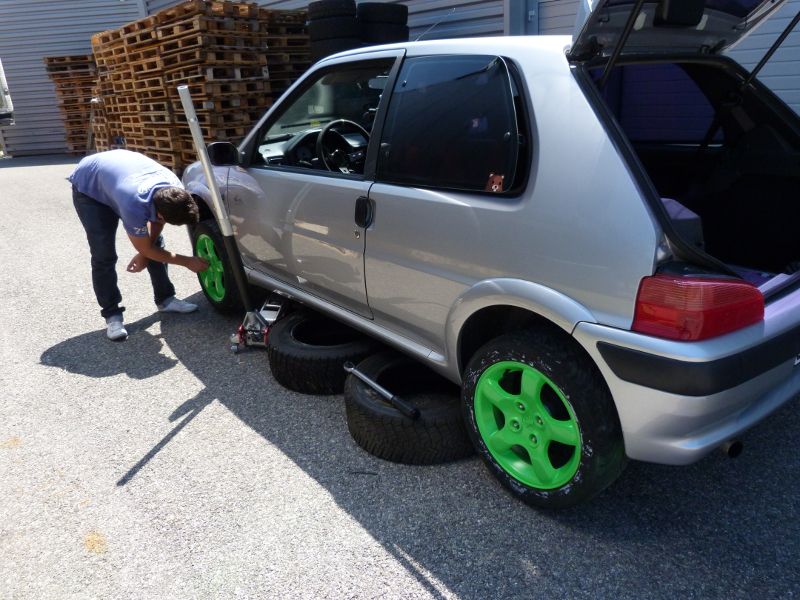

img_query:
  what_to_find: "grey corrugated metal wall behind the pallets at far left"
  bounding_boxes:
[0,0,144,156]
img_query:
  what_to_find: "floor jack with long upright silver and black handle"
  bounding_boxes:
[178,85,269,346]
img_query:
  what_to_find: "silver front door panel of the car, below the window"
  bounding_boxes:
[228,162,370,316]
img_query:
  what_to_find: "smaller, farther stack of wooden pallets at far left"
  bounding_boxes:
[44,54,97,153]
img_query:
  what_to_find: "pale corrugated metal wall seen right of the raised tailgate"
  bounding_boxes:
[730,0,800,114]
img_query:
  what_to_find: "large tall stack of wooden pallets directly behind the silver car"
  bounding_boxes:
[92,0,310,171]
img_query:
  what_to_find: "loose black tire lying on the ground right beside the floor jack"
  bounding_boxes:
[267,311,381,395]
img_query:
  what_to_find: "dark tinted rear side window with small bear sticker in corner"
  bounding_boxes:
[377,55,523,193]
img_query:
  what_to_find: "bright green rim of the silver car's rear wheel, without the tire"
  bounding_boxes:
[475,361,581,490]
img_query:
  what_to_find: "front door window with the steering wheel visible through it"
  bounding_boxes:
[253,59,394,174]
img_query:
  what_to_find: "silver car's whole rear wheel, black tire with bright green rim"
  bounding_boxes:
[462,331,626,508]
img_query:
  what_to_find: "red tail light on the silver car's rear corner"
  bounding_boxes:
[632,275,764,341]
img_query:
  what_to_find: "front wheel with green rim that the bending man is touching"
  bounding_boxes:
[192,219,244,314]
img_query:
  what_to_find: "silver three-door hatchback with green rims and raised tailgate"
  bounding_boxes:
[184,0,800,507]
